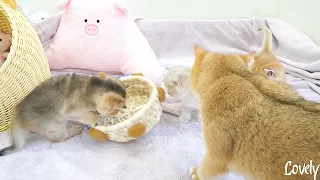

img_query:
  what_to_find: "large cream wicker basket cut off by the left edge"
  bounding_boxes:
[0,2,50,132]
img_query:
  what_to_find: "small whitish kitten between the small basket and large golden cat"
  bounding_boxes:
[164,66,199,123]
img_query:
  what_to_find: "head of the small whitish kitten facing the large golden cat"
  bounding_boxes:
[164,67,190,99]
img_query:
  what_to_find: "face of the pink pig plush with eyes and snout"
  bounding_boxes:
[61,0,127,37]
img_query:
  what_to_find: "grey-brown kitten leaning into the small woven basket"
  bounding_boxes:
[0,74,126,156]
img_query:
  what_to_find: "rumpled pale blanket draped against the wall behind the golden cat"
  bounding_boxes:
[146,18,320,115]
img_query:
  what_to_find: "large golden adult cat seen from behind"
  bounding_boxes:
[189,46,320,180]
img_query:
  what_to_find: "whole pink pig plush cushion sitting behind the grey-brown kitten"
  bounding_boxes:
[46,0,165,85]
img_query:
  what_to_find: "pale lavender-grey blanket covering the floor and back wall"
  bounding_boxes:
[0,18,320,180]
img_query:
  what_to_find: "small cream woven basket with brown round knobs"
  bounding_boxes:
[95,76,162,142]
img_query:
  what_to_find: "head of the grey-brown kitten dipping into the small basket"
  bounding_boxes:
[91,77,126,116]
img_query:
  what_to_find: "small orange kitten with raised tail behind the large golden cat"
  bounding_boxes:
[242,28,285,81]
